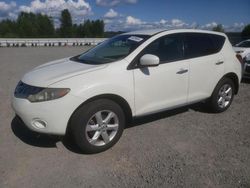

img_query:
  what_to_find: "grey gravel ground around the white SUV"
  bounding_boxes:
[0,47,250,188]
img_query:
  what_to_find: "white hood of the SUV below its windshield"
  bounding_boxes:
[22,58,107,87]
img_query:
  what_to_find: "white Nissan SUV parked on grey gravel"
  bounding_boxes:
[12,29,242,153]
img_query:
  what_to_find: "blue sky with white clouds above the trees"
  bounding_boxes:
[0,0,250,31]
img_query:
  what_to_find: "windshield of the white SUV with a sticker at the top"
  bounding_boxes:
[72,35,149,64]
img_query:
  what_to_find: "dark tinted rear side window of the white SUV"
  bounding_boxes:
[184,33,225,59]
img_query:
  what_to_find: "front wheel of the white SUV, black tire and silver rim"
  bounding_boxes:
[70,99,125,154]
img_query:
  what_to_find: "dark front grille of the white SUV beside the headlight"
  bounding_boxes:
[14,81,44,99]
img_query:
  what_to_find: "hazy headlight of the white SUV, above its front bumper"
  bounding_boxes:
[27,88,70,102]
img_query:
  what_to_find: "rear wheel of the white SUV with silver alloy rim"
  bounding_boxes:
[208,78,235,113]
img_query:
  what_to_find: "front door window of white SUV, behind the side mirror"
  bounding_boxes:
[143,34,183,63]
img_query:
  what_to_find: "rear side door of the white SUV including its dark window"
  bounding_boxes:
[184,33,225,103]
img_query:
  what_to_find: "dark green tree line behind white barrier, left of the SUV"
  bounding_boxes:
[0,9,104,38]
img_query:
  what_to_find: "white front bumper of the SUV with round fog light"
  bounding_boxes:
[11,94,82,135]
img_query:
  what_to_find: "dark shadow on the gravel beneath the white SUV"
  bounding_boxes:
[11,103,210,154]
